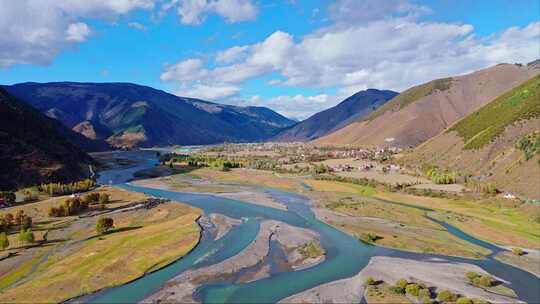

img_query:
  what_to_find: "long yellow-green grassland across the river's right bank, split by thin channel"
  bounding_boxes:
[188,169,540,257]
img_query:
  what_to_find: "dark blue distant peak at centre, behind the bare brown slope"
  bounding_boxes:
[272,89,398,141]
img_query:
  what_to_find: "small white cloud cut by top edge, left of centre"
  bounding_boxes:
[173,0,258,25]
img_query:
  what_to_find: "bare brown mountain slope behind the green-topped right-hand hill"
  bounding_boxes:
[314,64,539,147]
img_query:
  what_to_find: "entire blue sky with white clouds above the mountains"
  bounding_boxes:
[0,0,540,118]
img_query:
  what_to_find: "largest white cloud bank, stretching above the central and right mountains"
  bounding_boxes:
[162,16,540,117]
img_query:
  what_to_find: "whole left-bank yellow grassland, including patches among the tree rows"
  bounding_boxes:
[0,189,200,303]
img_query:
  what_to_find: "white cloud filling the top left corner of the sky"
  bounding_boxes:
[0,0,154,67]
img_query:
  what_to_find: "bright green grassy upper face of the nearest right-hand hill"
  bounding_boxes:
[448,76,540,149]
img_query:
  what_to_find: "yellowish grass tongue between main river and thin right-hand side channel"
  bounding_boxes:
[306,180,489,258]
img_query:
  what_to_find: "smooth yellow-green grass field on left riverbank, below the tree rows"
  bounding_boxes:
[0,203,200,303]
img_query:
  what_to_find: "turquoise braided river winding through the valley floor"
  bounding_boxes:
[83,152,540,303]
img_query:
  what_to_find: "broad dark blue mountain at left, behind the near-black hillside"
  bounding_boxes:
[5,82,295,147]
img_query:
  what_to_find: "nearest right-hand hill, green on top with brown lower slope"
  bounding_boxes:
[402,76,540,199]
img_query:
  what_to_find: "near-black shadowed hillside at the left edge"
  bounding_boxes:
[0,87,93,190]
